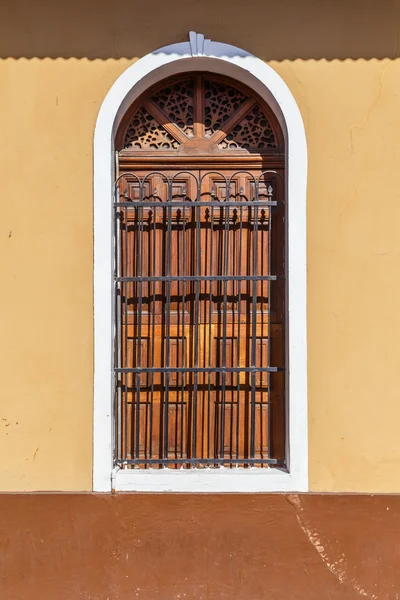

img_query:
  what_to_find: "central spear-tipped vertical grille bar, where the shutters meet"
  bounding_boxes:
[192,182,201,457]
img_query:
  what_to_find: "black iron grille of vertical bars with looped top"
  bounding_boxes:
[113,171,285,468]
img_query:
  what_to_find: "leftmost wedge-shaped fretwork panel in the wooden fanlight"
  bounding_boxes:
[124,107,180,150]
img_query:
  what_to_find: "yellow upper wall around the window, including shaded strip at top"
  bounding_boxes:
[0,0,400,492]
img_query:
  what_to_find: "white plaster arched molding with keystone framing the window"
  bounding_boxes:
[93,32,308,492]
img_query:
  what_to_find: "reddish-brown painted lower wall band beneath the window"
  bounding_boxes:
[0,494,400,600]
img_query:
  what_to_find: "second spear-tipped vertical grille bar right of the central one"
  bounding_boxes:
[250,179,259,458]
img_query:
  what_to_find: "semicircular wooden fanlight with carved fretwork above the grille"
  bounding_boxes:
[116,73,284,156]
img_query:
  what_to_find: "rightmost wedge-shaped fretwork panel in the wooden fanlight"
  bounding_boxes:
[219,106,277,150]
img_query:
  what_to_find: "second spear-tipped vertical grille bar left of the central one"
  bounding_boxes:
[135,182,143,458]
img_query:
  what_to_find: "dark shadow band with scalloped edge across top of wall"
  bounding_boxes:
[0,0,400,61]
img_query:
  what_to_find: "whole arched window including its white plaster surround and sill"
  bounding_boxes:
[94,34,307,491]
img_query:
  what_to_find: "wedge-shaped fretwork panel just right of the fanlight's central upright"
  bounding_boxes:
[204,79,247,137]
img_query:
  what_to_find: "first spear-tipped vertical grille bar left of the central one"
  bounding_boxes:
[163,180,172,458]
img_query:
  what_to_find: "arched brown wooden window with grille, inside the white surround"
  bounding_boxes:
[114,73,286,469]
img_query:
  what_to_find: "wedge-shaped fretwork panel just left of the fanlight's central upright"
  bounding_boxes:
[151,80,194,137]
